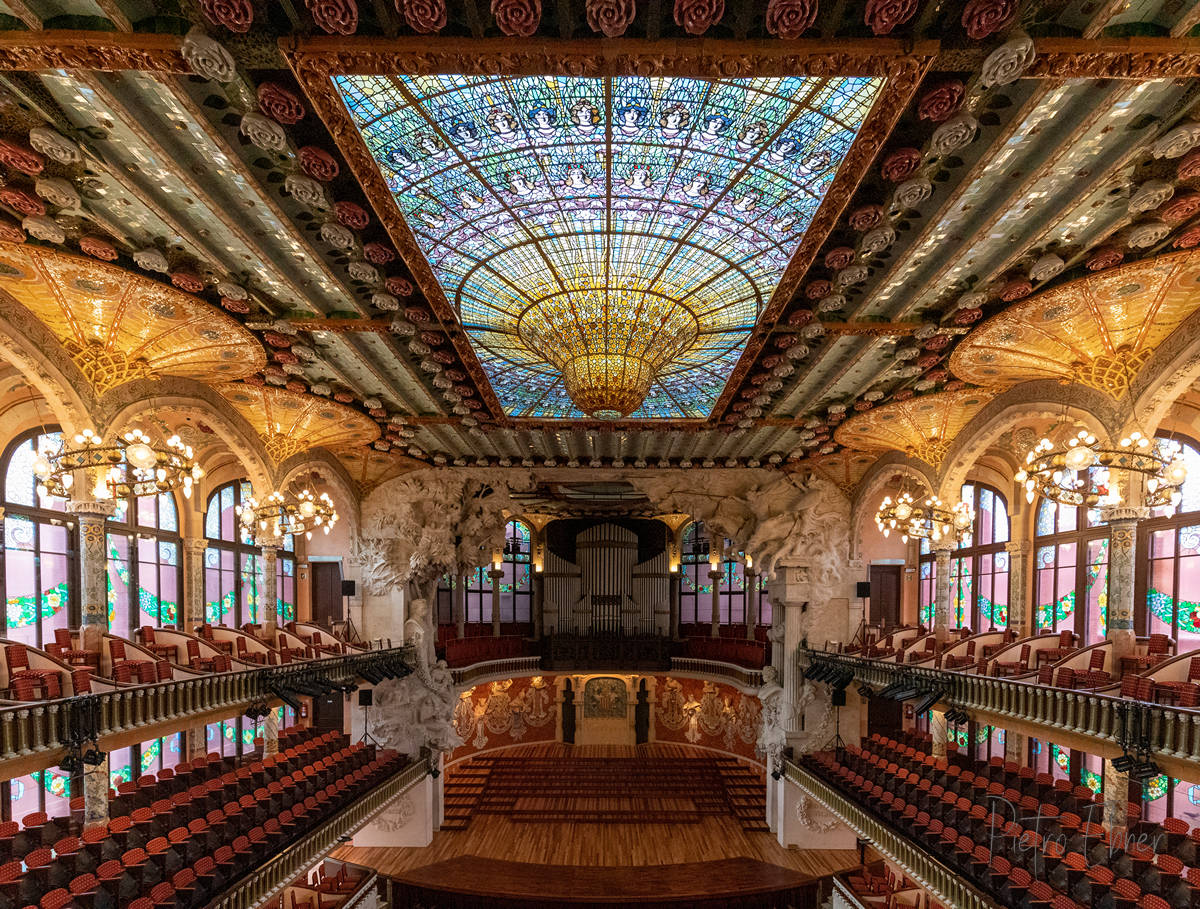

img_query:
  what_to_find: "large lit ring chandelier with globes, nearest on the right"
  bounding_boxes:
[1015,429,1188,508]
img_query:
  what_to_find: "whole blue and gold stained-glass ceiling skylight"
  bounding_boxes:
[337,76,882,419]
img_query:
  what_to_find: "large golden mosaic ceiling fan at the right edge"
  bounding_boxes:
[950,251,1200,397]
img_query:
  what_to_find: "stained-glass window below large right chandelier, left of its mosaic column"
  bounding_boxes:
[1033,499,1109,644]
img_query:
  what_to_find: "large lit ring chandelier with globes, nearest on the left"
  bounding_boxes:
[34,428,204,499]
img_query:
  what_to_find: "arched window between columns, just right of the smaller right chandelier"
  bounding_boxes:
[950,483,1008,631]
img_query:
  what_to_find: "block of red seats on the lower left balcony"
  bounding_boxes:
[0,728,403,909]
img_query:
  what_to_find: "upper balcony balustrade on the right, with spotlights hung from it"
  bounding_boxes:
[805,651,1200,772]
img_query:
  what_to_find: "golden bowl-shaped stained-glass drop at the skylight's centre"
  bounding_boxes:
[517,288,700,420]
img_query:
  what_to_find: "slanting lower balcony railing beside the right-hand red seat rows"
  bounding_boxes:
[784,761,997,909]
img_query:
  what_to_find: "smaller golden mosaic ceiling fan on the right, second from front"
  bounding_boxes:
[834,389,994,468]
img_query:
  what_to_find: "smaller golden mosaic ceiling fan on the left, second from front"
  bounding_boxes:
[217,384,379,464]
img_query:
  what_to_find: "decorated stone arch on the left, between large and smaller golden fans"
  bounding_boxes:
[96,377,275,495]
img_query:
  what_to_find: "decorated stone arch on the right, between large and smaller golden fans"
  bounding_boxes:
[936,379,1121,502]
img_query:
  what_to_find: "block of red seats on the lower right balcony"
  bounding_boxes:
[804,734,1200,909]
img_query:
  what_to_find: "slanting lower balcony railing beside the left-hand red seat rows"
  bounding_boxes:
[208,760,428,909]
